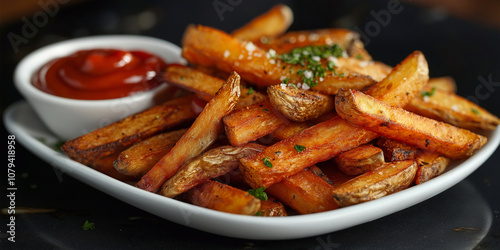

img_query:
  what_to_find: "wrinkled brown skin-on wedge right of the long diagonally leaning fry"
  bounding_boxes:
[160,143,265,198]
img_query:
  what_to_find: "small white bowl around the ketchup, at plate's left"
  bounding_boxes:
[14,35,184,140]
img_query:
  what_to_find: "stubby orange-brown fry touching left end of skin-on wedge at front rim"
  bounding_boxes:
[265,169,338,214]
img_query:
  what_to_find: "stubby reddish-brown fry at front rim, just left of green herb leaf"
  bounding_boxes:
[183,180,261,215]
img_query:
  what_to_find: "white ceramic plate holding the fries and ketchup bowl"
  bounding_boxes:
[4,101,500,240]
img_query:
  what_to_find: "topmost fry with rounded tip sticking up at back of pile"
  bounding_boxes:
[231,4,293,41]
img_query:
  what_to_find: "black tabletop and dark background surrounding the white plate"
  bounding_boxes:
[0,0,500,249]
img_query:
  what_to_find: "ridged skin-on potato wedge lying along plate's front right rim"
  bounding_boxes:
[332,160,417,207]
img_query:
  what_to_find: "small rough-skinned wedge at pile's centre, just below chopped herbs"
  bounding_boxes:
[267,84,334,122]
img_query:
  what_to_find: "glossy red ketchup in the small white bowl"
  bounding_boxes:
[32,49,167,100]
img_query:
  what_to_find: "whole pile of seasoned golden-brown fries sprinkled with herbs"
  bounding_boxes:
[62,5,500,216]
